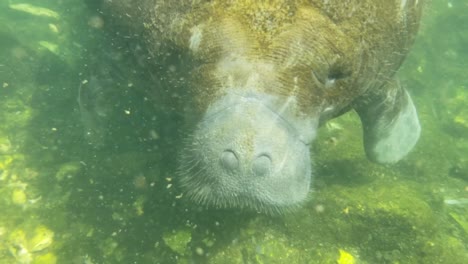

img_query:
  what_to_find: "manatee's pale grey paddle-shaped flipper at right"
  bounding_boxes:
[354,79,421,163]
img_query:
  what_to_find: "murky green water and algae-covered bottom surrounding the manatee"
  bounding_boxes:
[0,0,468,264]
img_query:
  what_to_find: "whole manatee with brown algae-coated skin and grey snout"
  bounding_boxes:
[96,0,423,212]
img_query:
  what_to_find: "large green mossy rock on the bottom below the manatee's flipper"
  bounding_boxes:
[286,178,437,263]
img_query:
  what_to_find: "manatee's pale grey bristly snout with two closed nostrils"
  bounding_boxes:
[179,92,314,212]
